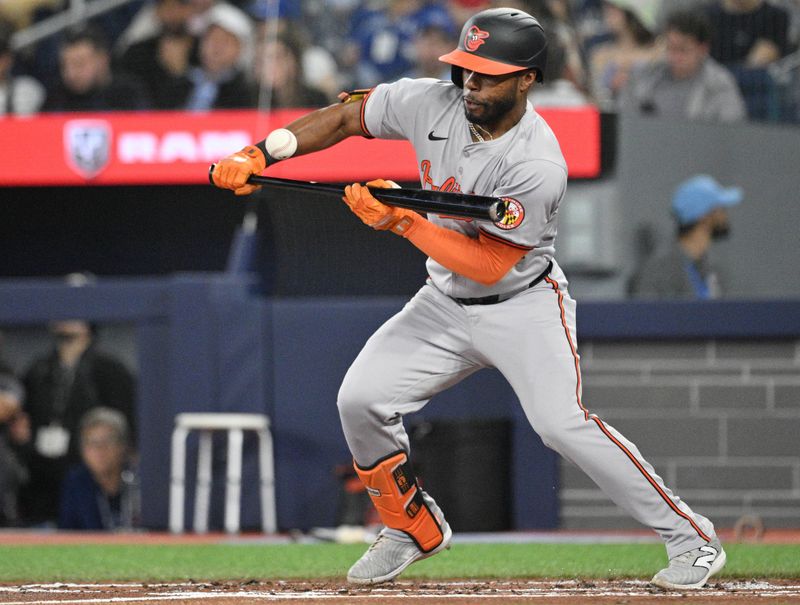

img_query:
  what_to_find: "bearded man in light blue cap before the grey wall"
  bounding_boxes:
[630,175,742,300]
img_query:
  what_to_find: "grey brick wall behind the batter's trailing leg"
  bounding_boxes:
[560,340,800,529]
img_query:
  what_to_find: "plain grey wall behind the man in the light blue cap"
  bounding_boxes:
[556,116,800,299]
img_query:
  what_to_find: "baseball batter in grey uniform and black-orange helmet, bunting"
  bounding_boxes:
[213,8,725,589]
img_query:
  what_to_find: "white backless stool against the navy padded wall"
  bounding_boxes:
[169,413,276,534]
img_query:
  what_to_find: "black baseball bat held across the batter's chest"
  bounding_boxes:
[208,164,506,222]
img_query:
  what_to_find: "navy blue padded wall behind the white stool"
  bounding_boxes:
[0,274,564,530]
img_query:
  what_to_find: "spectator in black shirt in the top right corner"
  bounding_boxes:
[708,0,789,67]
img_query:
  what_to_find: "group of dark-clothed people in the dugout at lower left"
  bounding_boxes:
[0,320,139,530]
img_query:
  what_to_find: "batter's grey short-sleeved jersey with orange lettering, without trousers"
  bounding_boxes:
[364,78,567,298]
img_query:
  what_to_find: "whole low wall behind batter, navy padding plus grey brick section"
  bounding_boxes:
[0,275,800,529]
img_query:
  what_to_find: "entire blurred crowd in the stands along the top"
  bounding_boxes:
[0,0,800,122]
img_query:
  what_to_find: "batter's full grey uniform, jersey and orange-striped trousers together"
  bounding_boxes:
[338,79,714,557]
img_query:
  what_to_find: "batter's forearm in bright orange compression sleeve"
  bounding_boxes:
[405,217,527,286]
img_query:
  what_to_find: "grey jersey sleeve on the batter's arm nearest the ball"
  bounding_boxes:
[364,78,436,139]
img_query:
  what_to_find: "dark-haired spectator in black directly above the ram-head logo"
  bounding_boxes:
[43,25,150,111]
